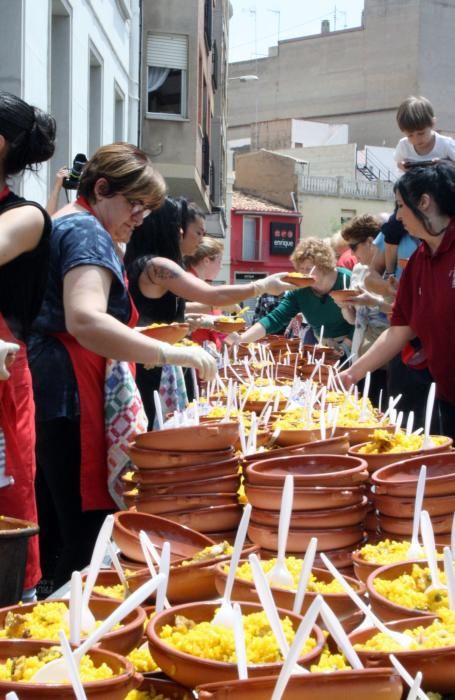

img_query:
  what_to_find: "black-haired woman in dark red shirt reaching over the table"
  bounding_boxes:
[342,164,455,437]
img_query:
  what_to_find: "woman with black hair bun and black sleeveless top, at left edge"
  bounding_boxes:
[0,91,55,596]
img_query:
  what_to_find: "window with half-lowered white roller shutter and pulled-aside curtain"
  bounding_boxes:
[147,34,188,118]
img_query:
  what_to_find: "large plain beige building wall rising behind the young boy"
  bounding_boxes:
[228,0,455,148]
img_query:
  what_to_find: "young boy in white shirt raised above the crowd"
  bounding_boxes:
[394,97,455,171]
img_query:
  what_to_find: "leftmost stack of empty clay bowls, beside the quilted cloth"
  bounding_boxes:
[124,421,242,540]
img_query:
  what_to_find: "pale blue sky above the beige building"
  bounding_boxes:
[229,0,364,62]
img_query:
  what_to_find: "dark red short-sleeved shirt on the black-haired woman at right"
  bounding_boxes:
[391,218,455,404]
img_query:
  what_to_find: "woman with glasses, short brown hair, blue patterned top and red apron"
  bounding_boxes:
[29,143,216,587]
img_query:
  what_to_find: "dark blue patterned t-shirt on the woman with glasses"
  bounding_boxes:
[28,213,131,420]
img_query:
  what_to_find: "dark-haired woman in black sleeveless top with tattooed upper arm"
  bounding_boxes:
[125,197,291,429]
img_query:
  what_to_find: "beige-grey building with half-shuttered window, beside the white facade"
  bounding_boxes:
[141,0,230,235]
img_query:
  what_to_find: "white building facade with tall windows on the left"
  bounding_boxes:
[0,0,140,204]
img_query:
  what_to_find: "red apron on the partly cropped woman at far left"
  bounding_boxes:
[0,314,41,588]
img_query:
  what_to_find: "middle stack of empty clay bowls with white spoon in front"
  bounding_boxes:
[244,454,368,568]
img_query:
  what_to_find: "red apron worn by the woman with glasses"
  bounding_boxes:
[54,297,139,511]
